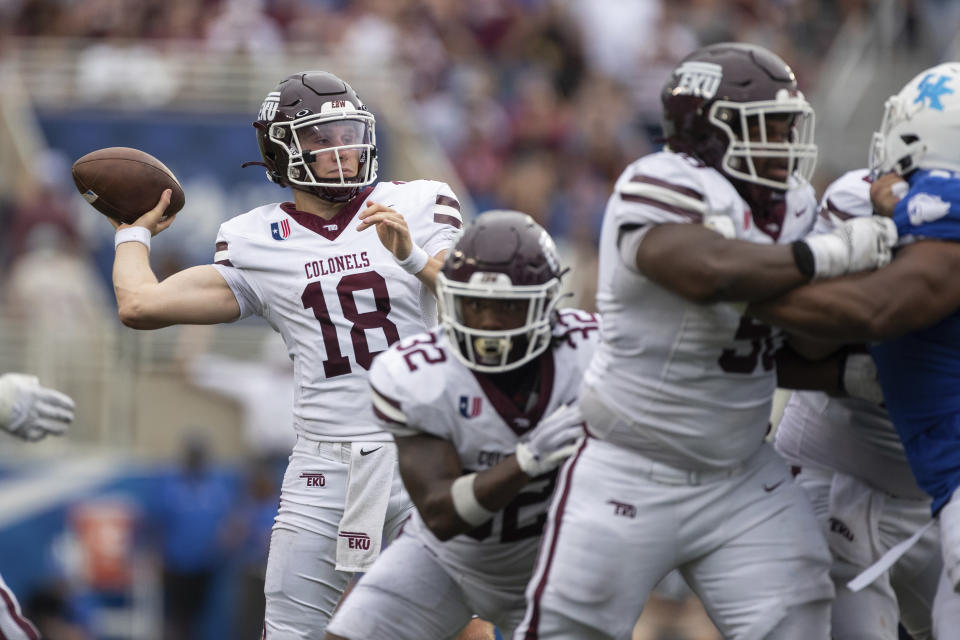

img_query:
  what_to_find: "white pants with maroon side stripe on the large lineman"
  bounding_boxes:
[514,438,833,640]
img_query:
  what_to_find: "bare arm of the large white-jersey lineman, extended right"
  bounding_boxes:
[636,224,810,304]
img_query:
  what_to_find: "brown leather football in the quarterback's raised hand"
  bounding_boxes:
[72,147,185,224]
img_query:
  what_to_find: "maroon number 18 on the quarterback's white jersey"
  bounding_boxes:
[300,271,400,378]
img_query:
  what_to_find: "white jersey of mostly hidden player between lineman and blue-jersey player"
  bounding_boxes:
[775,169,925,499]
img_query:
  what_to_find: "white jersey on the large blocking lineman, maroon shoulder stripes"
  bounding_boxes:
[585,151,817,469]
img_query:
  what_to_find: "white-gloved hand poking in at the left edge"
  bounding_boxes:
[0,373,74,441]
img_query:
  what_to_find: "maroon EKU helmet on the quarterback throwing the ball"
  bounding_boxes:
[253,71,377,202]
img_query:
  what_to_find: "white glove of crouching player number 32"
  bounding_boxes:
[517,405,585,478]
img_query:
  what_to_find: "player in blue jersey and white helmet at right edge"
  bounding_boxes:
[748,62,960,638]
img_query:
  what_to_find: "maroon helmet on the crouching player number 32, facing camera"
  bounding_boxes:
[437,210,563,373]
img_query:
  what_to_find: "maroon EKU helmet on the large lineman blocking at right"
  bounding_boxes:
[660,42,817,192]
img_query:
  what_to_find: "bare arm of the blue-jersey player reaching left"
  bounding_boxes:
[746,240,960,342]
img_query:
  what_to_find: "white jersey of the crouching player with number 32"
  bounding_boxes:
[370,309,599,588]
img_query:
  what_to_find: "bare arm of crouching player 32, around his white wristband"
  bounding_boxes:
[395,434,530,540]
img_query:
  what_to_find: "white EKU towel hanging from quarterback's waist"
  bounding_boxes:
[337,442,397,571]
